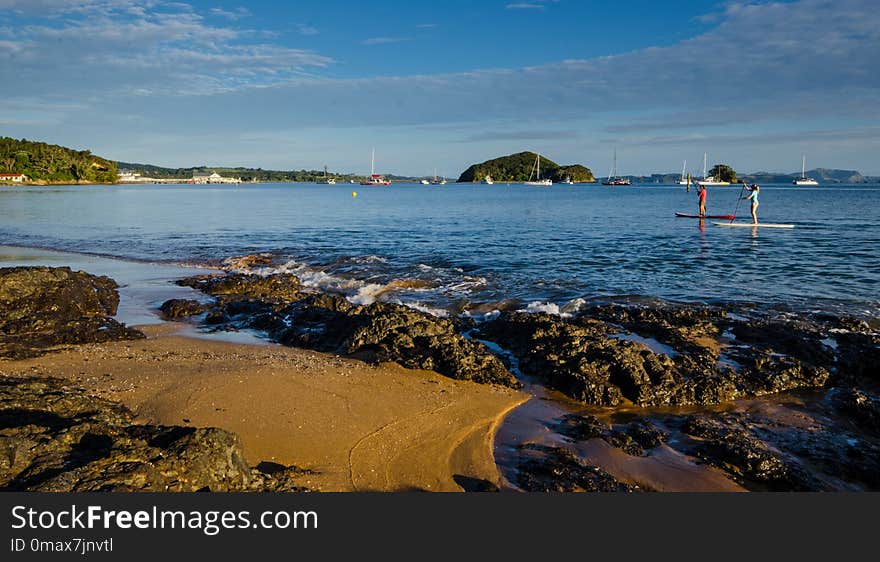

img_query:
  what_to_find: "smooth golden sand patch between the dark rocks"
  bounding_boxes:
[0,324,528,491]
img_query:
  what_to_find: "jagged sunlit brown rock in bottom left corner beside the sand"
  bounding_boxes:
[0,377,310,492]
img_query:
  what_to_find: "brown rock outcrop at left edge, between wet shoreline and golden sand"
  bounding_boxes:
[0,267,143,358]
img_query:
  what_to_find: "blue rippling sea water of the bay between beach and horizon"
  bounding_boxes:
[0,184,880,318]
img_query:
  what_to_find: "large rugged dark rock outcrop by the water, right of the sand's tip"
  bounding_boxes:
[478,307,830,406]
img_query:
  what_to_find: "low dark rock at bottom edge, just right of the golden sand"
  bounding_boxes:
[516,444,641,492]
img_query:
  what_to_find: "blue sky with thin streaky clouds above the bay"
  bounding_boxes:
[0,0,880,176]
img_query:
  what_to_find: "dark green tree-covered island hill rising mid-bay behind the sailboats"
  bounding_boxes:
[458,152,596,183]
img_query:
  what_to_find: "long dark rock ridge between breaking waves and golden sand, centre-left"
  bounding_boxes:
[182,274,520,387]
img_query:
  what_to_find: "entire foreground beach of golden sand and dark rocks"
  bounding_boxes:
[0,254,880,492]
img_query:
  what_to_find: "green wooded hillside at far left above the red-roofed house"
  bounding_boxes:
[0,137,116,183]
